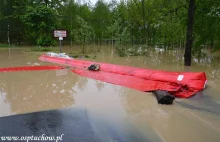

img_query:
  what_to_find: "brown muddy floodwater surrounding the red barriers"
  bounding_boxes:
[0,46,220,142]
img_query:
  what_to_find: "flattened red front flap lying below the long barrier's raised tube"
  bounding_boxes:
[72,69,197,98]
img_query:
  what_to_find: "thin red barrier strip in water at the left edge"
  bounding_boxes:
[0,66,65,72]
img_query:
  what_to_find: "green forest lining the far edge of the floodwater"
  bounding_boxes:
[0,0,220,53]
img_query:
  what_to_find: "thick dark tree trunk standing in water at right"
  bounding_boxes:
[184,0,195,66]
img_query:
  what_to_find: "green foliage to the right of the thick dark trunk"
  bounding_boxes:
[192,0,220,55]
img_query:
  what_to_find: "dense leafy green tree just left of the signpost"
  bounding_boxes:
[21,5,57,46]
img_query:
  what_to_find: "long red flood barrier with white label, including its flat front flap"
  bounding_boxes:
[39,54,207,98]
